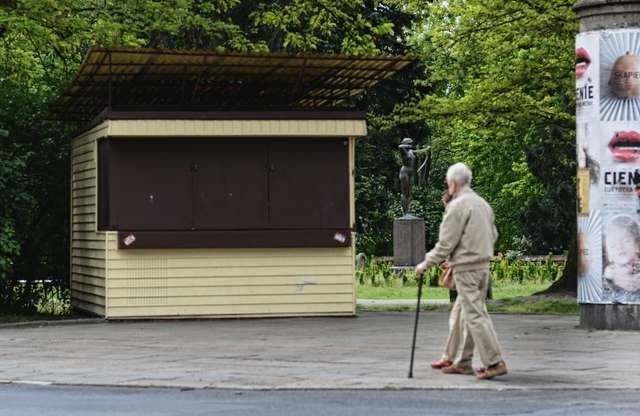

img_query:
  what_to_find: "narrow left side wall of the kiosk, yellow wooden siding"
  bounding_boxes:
[70,122,108,316]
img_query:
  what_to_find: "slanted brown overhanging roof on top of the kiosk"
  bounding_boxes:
[50,48,413,121]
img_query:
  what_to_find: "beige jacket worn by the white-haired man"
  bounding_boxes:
[425,187,498,271]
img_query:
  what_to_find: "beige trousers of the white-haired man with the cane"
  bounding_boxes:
[443,270,502,367]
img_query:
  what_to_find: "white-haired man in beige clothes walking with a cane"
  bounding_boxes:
[416,163,507,379]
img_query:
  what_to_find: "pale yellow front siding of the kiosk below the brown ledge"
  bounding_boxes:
[107,232,355,318]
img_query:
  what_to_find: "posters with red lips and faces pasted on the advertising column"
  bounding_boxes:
[576,29,640,303]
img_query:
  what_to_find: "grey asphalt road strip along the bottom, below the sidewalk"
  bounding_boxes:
[0,385,640,416]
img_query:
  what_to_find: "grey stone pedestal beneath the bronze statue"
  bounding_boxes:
[393,214,425,267]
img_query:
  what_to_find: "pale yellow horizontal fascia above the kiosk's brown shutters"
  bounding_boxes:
[104,120,367,137]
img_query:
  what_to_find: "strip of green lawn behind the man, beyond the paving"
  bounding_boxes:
[358,282,550,299]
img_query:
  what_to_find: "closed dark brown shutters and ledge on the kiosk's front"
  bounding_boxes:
[99,138,350,249]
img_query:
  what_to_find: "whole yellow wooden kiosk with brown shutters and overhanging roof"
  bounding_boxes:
[52,49,410,319]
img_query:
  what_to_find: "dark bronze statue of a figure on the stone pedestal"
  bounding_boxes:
[398,137,431,215]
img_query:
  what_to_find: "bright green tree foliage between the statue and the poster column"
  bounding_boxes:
[399,0,577,253]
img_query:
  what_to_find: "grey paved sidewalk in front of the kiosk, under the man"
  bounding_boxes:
[0,312,640,389]
